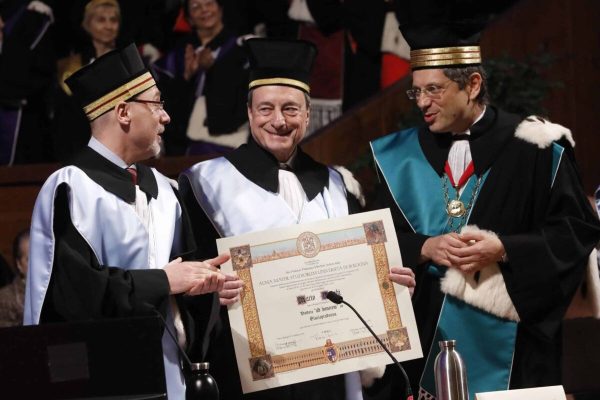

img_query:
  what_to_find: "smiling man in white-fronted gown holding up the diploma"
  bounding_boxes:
[179,39,414,400]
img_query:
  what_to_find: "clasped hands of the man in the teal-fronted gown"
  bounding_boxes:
[421,232,505,273]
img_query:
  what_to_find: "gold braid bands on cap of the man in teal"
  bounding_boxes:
[410,46,481,69]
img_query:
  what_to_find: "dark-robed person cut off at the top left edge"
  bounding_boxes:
[0,0,54,165]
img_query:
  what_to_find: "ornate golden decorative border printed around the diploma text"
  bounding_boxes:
[230,221,411,381]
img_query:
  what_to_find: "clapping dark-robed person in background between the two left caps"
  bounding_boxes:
[154,0,248,154]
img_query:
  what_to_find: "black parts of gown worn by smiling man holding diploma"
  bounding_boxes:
[179,139,360,400]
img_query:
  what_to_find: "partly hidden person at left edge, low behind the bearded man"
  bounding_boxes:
[0,229,29,328]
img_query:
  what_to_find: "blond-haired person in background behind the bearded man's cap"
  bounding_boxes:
[54,0,121,162]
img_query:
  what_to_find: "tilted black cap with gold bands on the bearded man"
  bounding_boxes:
[65,43,156,121]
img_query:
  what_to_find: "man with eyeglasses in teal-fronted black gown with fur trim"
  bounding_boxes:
[371,1,600,398]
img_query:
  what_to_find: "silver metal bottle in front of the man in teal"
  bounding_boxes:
[434,340,469,400]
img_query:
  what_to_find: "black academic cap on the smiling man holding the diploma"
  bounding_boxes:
[245,38,317,93]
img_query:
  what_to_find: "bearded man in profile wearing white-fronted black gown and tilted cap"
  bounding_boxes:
[24,44,229,399]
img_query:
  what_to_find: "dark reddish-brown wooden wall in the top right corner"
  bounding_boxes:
[481,0,600,194]
